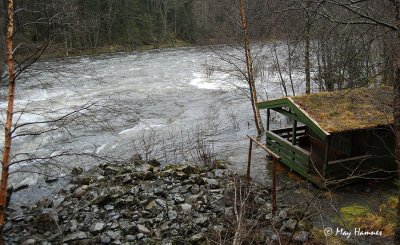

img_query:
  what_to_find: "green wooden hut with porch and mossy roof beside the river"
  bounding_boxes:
[258,87,396,186]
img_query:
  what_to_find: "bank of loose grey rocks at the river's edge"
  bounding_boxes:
[4,160,310,245]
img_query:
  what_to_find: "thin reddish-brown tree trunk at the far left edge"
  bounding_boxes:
[0,0,15,241]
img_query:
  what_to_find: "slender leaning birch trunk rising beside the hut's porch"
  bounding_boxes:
[240,0,264,136]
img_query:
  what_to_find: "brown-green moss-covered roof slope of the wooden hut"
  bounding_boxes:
[290,87,393,133]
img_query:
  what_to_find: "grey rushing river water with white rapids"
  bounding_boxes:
[0,48,300,205]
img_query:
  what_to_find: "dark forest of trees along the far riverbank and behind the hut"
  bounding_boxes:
[0,0,395,90]
